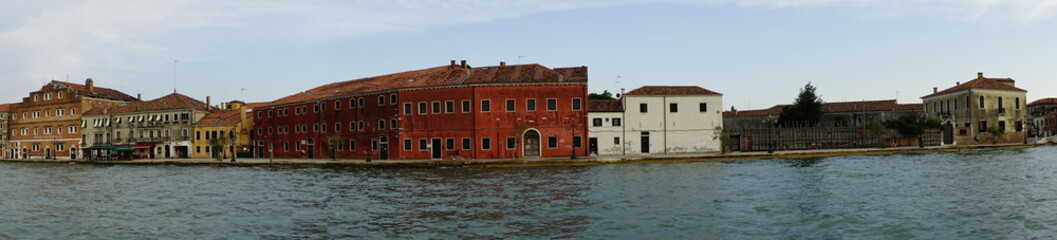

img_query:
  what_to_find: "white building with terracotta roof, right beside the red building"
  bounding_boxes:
[588,86,723,155]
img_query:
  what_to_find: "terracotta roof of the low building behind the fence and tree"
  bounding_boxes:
[723,99,925,117]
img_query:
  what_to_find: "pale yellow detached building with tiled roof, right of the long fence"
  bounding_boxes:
[922,73,1027,145]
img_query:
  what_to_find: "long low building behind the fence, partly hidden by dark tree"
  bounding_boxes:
[723,99,925,129]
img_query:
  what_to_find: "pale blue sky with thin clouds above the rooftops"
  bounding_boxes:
[0,0,1057,110]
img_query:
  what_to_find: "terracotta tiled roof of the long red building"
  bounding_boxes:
[257,64,588,108]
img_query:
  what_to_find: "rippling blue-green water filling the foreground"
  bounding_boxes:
[0,144,1057,239]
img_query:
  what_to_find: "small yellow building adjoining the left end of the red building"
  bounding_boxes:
[191,100,254,159]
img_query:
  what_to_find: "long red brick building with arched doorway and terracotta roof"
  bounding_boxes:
[253,61,588,160]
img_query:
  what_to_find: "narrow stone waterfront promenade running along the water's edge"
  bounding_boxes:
[0,144,1043,168]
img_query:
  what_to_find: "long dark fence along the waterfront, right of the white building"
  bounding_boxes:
[724,127,941,151]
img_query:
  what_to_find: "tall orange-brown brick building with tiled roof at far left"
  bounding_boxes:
[8,78,138,159]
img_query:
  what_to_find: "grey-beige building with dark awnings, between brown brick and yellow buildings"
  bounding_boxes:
[81,93,208,159]
